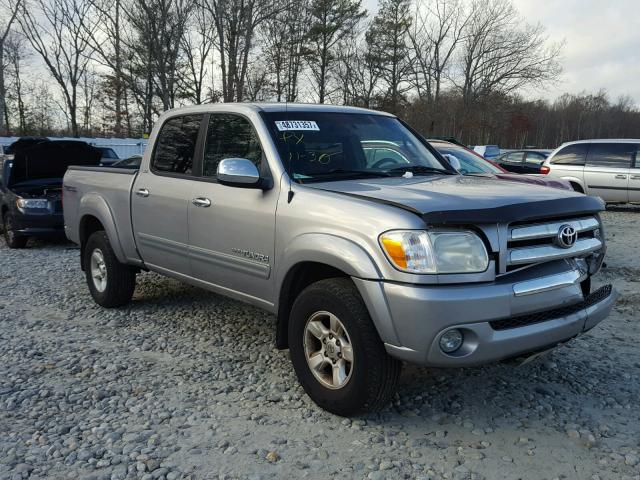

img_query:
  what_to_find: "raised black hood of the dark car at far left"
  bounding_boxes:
[10,140,101,185]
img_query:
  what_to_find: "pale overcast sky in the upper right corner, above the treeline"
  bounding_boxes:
[363,0,640,106]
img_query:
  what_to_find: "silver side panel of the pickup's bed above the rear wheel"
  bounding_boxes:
[62,166,141,264]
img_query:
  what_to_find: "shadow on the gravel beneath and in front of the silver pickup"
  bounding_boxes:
[121,274,640,441]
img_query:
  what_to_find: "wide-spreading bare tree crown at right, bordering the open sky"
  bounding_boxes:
[457,0,561,104]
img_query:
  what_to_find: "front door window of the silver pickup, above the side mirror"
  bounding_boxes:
[202,113,262,177]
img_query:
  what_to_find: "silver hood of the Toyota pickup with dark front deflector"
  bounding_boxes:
[307,175,604,224]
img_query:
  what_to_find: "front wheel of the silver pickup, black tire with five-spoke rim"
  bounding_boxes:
[289,278,401,416]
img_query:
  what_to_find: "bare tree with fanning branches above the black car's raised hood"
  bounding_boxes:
[18,0,96,137]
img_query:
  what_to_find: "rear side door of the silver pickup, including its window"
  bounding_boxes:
[131,115,204,275]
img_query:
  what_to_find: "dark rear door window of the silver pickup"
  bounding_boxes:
[151,115,203,175]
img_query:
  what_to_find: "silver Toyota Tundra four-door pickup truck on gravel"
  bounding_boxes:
[63,104,616,415]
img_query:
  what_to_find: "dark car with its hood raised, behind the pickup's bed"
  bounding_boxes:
[0,140,100,248]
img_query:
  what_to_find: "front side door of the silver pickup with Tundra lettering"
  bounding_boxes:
[189,113,279,303]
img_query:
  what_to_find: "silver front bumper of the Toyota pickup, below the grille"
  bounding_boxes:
[355,261,618,367]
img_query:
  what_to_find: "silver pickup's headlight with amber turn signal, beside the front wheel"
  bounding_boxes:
[380,230,489,273]
